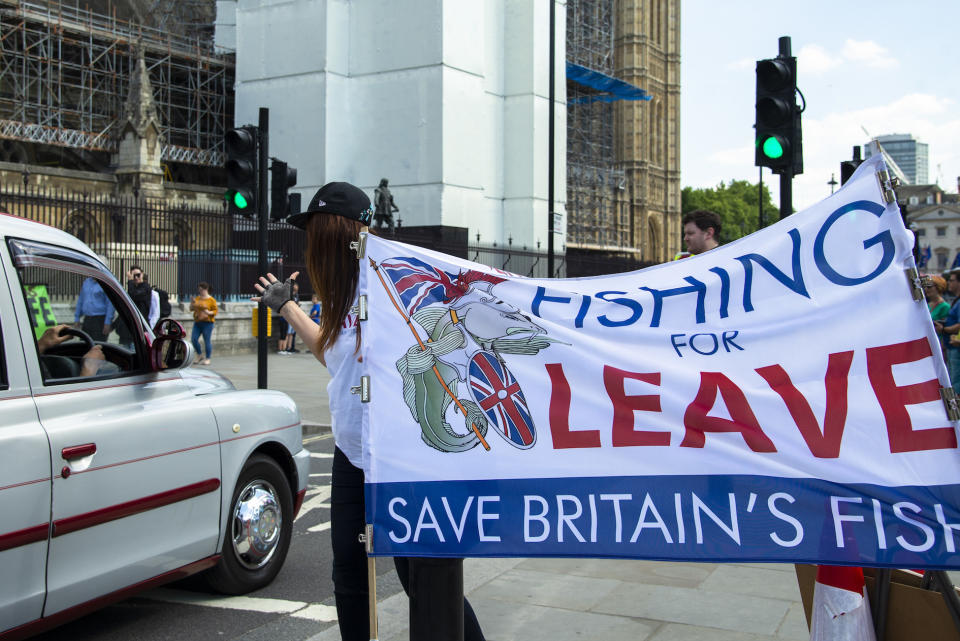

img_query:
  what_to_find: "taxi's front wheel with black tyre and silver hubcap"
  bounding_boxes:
[206,454,293,594]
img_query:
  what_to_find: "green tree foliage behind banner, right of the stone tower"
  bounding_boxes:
[680,180,780,243]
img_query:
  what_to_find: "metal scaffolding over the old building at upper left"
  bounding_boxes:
[0,0,235,166]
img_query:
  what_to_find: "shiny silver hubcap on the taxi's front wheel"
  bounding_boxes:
[233,480,283,570]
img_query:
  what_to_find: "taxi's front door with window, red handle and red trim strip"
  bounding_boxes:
[9,240,220,616]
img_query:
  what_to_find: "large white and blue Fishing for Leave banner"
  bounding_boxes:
[360,157,960,568]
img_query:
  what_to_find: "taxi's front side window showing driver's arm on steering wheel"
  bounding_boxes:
[17,263,146,384]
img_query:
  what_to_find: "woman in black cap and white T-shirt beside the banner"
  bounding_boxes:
[253,182,484,641]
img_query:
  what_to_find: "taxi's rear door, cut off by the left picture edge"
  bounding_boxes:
[0,248,50,633]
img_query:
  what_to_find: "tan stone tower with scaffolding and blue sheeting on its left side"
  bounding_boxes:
[566,0,681,264]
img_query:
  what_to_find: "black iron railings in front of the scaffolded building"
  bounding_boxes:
[0,180,649,302]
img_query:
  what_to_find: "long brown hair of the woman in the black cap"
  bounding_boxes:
[306,213,361,352]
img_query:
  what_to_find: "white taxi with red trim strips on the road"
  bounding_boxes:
[0,214,310,641]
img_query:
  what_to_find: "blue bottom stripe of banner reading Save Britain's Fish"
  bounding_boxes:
[366,475,960,569]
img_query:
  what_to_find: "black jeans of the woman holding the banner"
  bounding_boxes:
[330,447,483,641]
